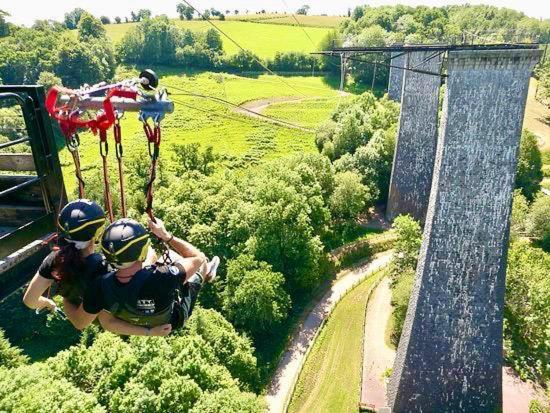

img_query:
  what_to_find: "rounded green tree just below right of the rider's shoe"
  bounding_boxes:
[223,255,290,335]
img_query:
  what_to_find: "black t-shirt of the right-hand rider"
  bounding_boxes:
[83,265,185,315]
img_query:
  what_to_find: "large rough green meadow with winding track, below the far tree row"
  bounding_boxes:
[61,70,339,193]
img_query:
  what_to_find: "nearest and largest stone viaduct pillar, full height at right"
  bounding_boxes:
[388,49,540,412]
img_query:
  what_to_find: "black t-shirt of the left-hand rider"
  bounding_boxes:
[38,251,110,305]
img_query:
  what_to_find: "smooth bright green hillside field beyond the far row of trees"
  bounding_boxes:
[105,20,331,58]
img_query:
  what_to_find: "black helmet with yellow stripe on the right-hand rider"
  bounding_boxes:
[101,218,149,267]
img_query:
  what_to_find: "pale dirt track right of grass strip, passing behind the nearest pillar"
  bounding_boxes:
[361,278,546,413]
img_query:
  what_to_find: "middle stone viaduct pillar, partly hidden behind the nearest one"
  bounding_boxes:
[386,52,441,222]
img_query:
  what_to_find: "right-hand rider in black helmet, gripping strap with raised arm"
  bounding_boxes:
[78,218,219,335]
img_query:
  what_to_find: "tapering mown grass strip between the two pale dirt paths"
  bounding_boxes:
[288,273,380,413]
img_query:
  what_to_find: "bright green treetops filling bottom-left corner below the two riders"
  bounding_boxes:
[0,308,263,413]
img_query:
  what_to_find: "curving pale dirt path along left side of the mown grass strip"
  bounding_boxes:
[266,252,391,413]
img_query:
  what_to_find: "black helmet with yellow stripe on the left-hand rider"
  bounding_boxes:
[58,199,105,241]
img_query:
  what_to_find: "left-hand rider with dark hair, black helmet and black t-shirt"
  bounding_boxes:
[23,199,169,335]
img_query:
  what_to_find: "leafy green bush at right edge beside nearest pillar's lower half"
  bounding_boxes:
[504,241,550,383]
